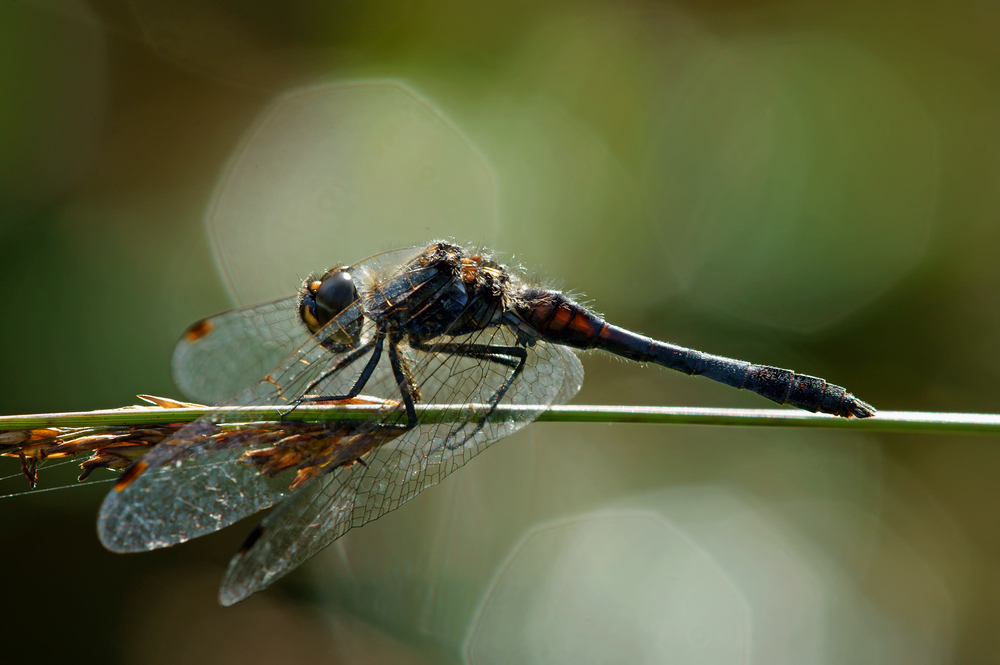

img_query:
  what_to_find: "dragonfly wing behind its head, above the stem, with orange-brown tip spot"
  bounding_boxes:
[171,296,309,404]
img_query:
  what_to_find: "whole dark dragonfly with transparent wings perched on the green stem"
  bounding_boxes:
[98,241,875,605]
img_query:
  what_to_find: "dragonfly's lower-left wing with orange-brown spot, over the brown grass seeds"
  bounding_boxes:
[98,250,432,552]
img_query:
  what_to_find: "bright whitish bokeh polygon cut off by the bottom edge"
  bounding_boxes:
[466,510,750,663]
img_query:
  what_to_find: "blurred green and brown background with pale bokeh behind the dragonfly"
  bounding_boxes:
[0,0,1000,665]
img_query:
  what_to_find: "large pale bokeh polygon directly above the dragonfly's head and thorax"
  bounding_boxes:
[206,81,497,304]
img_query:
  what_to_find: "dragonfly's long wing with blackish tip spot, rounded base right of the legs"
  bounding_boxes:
[220,329,583,605]
